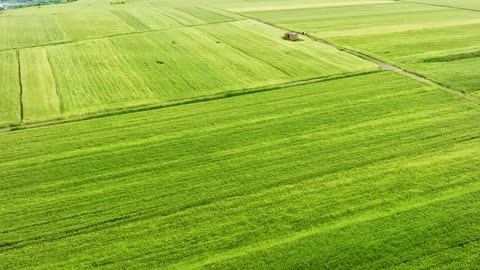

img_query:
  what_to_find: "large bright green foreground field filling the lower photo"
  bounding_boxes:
[0,72,480,269]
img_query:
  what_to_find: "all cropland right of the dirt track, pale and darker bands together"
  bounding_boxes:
[245,1,480,95]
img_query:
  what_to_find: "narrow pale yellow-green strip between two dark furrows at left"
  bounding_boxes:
[20,48,61,122]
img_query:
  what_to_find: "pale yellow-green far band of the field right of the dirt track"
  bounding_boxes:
[246,2,480,38]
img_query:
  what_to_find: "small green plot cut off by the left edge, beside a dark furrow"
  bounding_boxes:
[0,51,20,127]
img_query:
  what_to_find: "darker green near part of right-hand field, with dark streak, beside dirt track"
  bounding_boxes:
[329,24,480,95]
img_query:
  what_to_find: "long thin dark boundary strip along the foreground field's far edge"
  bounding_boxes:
[0,69,382,133]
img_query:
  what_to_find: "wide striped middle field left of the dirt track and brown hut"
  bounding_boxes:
[0,20,378,123]
